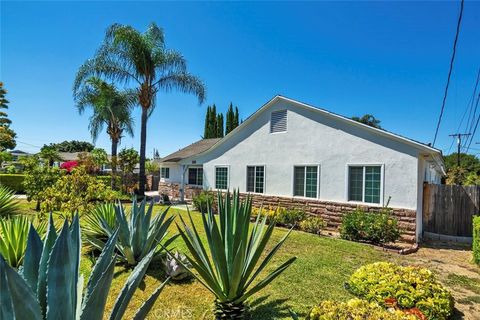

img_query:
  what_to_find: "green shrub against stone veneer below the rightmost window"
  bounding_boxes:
[340,208,400,244]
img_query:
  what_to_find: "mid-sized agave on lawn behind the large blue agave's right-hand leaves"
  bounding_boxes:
[85,199,176,266]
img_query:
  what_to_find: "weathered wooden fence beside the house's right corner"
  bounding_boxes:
[423,184,480,237]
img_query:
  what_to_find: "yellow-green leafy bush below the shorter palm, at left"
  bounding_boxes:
[40,167,117,213]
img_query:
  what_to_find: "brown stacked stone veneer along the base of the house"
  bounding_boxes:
[159,182,416,243]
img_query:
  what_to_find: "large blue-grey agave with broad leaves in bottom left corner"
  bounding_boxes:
[0,216,169,320]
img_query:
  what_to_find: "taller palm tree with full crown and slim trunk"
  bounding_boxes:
[74,23,205,196]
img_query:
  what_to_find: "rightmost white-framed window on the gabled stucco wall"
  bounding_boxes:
[348,165,382,204]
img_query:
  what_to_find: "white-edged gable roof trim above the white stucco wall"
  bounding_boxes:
[191,95,443,160]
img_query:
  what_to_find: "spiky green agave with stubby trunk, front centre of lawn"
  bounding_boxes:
[177,192,296,319]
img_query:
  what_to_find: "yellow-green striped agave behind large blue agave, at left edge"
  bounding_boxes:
[0,216,47,268]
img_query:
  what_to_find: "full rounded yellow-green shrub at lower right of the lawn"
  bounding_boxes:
[346,262,454,320]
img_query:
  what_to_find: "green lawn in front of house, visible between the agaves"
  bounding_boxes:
[17,203,402,319]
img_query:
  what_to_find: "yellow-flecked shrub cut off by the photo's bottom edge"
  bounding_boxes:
[306,299,417,320]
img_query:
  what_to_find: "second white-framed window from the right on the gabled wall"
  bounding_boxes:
[293,166,318,198]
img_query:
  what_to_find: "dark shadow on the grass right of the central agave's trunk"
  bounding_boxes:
[250,295,290,320]
